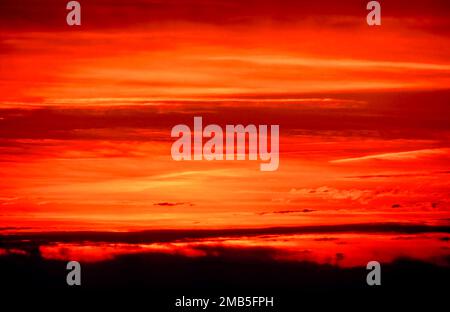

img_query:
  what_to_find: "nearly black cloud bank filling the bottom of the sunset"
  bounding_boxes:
[0,248,450,302]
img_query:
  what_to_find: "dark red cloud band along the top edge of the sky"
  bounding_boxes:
[0,0,449,32]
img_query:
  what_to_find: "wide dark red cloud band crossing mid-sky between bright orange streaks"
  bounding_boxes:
[0,91,450,141]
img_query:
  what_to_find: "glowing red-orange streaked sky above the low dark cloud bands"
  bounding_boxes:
[0,0,450,236]
